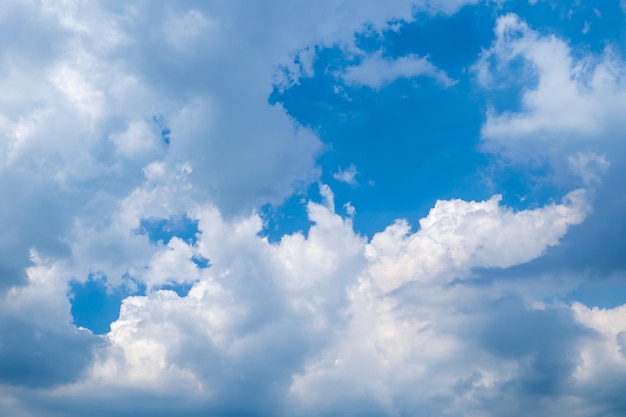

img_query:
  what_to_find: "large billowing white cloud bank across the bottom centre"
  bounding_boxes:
[2,189,587,415]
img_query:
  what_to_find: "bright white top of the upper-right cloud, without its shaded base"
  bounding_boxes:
[474,14,626,157]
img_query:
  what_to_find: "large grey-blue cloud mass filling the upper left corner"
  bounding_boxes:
[0,0,478,288]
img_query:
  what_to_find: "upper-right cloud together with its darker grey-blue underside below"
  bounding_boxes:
[473,14,626,277]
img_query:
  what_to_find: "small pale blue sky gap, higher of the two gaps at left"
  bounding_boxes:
[136,215,198,245]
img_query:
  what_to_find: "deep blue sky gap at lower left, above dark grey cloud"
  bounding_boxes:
[69,275,146,334]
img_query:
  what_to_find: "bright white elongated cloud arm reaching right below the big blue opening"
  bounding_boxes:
[367,190,589,292]
